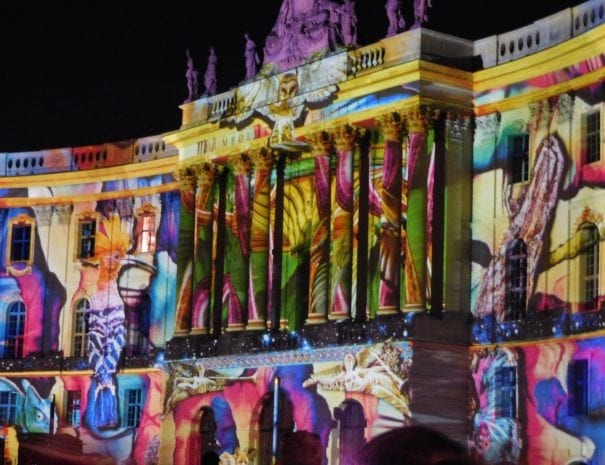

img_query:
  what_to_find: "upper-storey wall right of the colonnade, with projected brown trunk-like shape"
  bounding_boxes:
[472,83,605,342]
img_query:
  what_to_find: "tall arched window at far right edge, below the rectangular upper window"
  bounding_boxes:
[580,224,599,310]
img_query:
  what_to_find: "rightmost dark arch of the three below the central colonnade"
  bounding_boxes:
[334,399,367,465]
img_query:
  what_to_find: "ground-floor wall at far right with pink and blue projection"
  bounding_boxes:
[471,336,605,465]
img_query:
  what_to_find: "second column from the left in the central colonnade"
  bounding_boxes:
[191,163,220,334]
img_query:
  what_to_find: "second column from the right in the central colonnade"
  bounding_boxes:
[376,113,403,315]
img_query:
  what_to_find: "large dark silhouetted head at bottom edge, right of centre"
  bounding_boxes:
[357,425,482,465]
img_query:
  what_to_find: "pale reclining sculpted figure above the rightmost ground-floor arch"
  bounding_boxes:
[303,342,411,416]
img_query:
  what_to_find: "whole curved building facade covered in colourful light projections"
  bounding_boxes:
[0,0,605,465]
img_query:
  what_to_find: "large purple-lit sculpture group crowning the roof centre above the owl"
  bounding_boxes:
[263,0,344,71]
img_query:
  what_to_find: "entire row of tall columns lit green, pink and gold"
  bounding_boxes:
[175,109,436,335]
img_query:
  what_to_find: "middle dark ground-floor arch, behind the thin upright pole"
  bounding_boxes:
[257,382,294,465]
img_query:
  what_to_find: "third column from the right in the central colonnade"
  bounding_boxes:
[329,126,357,320]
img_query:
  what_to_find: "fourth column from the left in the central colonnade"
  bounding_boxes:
[246,149,273,330]
